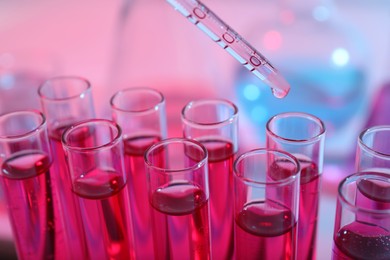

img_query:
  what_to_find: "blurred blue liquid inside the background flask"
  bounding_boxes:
[235,61,369,160]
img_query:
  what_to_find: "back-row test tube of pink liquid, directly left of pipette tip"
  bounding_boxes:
[182,99,238,259]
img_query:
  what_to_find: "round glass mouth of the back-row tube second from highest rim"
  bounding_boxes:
[110,87,165,114]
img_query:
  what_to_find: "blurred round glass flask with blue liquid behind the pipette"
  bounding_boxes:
[235,0,370,161]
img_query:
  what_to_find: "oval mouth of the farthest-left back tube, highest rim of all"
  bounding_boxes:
[38,76,91,101]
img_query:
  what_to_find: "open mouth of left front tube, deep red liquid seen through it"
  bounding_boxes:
[62,119,122,151]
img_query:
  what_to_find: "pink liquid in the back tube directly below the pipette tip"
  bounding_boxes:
[272,158,321,259]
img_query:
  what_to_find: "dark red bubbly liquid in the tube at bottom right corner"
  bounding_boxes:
[332,222,390,260]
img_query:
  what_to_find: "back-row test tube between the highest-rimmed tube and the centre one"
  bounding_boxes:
[111,87,167,259]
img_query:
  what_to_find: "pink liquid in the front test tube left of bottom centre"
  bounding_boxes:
[151,183,210,260]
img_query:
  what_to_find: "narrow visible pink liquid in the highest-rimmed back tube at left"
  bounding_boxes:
[49,125,88,259]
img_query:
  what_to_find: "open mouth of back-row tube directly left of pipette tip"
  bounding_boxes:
[181,99,238,128]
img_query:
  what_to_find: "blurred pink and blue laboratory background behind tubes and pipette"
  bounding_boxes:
[0,0,390,259]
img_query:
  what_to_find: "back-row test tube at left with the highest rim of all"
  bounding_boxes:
[38,76,95,259]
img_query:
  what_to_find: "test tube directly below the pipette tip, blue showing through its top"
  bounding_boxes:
[266,112,325,259]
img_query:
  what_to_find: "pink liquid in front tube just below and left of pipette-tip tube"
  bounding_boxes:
[235,201,296,260]
